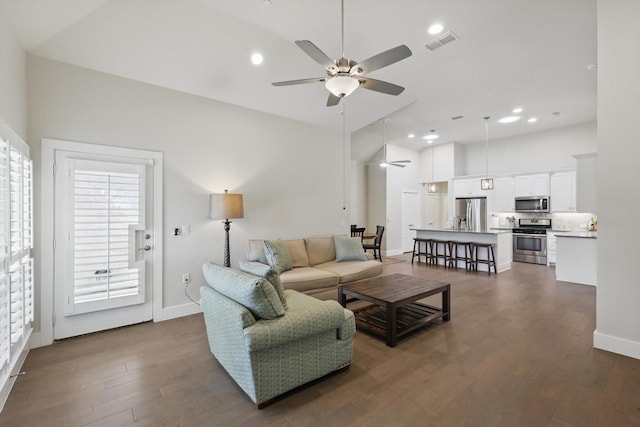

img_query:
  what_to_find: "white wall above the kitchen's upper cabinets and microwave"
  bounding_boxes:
[463,122,598,175]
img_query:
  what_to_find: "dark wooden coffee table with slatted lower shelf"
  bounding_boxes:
[338,274,451,347]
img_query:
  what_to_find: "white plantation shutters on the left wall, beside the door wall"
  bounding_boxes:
[0,121,34,378]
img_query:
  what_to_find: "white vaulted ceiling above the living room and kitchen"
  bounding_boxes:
[0,0,597,160]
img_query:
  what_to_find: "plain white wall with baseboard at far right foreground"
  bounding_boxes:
[594,0,640,359]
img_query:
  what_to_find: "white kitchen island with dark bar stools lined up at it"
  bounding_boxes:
[412,228,513,273]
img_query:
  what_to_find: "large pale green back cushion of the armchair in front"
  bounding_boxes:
[202,263,285,319]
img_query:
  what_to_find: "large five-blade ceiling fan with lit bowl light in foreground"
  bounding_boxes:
[272,0,411,107]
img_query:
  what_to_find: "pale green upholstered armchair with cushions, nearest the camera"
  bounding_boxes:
[201,264,355,408]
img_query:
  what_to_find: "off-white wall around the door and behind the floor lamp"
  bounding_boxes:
[28,56,349,332]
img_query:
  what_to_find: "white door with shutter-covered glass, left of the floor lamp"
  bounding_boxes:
[53,151,153,339]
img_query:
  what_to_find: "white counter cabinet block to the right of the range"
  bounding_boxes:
[556,231,598,286]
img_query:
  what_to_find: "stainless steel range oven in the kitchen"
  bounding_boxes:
[513,218,551,264]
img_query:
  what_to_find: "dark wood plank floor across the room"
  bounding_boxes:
[0,256,640,427]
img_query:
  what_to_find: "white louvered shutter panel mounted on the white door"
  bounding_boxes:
[66,160,144,314]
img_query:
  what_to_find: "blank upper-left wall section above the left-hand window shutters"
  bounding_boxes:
[0,9,27,137]
